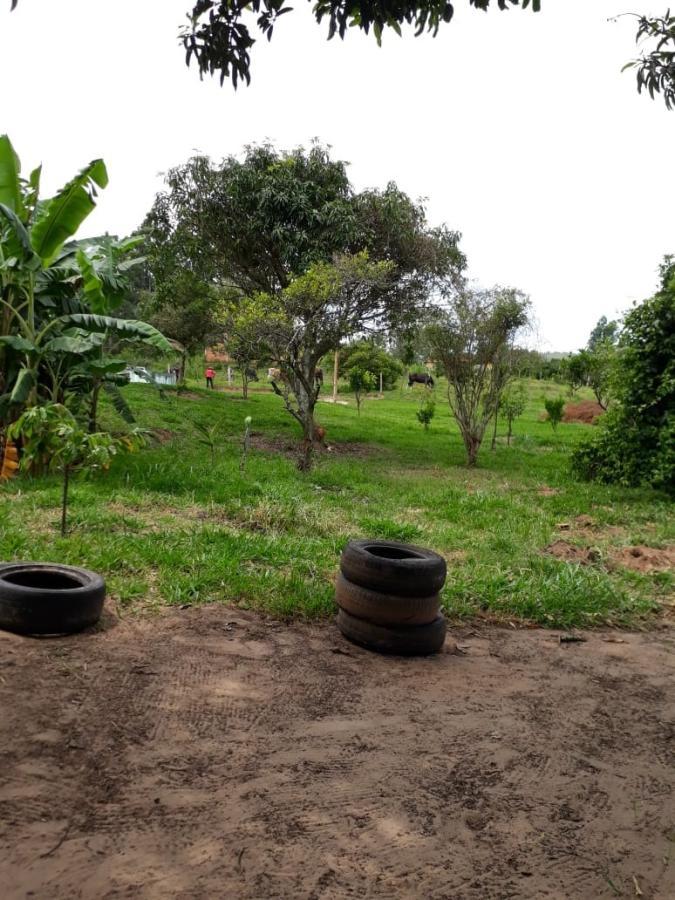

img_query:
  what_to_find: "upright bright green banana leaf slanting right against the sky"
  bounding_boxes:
[31,159,108,266]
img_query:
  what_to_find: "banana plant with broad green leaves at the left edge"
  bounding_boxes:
[0,135,171,419]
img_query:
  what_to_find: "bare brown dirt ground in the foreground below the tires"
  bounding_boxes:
[0,607,675,900]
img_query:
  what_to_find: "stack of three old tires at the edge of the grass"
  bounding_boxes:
[335,540,447,656]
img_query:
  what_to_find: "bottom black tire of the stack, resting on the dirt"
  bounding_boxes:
[337,609,447,656]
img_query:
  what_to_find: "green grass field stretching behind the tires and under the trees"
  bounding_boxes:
[0,382,674,628]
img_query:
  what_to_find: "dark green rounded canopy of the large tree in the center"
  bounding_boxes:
[145,144,465,294]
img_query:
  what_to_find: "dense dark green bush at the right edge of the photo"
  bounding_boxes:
[572,257,675,493]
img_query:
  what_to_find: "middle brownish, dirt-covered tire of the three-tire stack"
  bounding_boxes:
[335,572,441,625]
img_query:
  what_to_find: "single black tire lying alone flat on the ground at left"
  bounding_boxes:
[0,562,105,634]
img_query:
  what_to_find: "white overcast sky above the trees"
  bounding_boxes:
[0,0,675,350]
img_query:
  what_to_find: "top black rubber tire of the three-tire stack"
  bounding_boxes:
[340,540,448,597]
